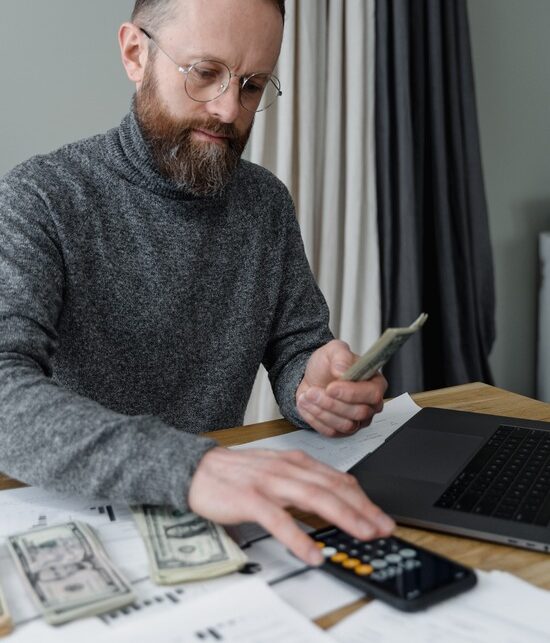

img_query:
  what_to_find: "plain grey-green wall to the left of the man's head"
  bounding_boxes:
[0,0,133,175]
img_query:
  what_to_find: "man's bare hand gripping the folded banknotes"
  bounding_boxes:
[296,339,388,437]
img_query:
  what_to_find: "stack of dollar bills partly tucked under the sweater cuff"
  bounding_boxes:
[132,505,247,585]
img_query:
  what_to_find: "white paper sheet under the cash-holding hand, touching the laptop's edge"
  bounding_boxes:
[232,393,420,471]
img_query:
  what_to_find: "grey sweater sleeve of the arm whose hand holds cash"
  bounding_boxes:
[263,195,333,428]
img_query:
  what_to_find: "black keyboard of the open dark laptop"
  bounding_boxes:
[435,426,550,526]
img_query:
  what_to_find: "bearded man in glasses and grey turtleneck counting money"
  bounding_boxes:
[0,0,394,564]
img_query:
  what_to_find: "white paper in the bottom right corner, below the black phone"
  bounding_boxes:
[330,571,550,643]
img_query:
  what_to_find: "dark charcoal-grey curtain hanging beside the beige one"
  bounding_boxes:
[375,0,495,395]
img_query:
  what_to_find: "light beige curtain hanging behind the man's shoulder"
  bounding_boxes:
[245,0,380,424]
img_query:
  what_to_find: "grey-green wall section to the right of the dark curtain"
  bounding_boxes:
[468,0,550,396]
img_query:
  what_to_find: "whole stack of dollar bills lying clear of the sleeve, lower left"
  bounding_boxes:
[7,522,135,625]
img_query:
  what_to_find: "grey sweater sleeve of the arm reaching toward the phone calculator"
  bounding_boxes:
[0,172,216,509]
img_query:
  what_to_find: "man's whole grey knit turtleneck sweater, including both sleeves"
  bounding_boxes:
[0,113,332,508]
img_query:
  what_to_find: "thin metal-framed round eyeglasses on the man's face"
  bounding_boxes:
[139,27,283,112]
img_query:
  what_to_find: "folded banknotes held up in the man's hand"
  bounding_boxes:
[342,313,428,382]
